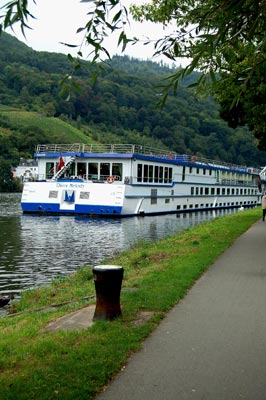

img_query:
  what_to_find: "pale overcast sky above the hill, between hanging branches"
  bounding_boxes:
[7,0,188,66]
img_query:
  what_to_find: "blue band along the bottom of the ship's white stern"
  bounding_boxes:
[21,203,122,216]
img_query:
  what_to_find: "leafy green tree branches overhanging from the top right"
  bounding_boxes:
[0,0,266,150]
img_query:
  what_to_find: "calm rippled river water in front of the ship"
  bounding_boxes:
[0,193,237,295]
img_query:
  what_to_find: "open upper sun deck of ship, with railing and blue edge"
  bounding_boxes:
[35,143,260,174]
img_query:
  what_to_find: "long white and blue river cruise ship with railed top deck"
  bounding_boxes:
[21,143,261,217]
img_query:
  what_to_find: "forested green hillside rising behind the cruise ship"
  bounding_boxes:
[0,33,265,166]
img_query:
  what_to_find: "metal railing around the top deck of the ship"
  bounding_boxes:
[36,143,261,174]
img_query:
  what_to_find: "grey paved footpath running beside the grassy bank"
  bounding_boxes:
[96,221,266,400]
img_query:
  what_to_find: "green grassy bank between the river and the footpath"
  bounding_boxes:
[0,208,261,400]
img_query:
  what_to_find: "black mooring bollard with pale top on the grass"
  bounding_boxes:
[93,265,124,321]
